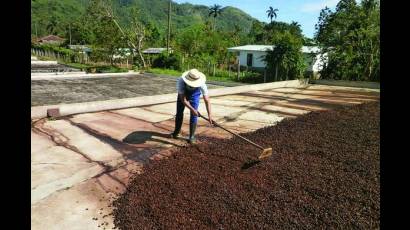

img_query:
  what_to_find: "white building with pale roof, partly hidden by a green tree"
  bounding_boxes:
[228,45,323,73]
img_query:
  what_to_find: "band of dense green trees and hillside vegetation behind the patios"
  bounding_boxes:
[32,0,380,82]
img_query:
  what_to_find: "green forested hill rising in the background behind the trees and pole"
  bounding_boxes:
[31,0,256,36]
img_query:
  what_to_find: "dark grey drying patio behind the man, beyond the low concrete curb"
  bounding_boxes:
[31,73,226,106]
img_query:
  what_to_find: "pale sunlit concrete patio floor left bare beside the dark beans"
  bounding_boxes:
[31,83,380,229]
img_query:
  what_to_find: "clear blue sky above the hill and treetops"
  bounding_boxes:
[173,0,339,38]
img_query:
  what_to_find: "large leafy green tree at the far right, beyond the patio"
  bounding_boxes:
[315,0,380,81]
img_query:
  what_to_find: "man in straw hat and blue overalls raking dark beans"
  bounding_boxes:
[171,69,212,144]
